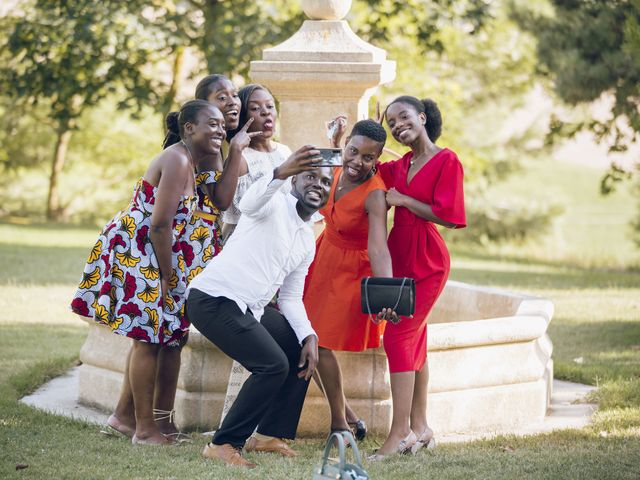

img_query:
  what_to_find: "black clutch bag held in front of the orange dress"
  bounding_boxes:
[360,277,416,317]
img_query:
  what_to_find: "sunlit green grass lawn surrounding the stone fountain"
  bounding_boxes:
[0,160,640,479]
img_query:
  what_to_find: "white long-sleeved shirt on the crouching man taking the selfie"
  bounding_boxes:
[187,172,315,343]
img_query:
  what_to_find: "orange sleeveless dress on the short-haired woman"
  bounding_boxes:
[304,168,386,352]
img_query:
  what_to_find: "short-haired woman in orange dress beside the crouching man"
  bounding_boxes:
[304,120,392,436]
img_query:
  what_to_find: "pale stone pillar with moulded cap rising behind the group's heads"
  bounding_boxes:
[249,16,395,150]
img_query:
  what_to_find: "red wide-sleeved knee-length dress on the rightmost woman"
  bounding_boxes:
[378,148,466,373]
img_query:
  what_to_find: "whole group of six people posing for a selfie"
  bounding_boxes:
[71,75,466,468]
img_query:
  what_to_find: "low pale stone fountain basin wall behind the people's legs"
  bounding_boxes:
[80,282,553,437]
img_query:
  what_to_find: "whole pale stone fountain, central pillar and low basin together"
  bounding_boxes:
[79,0,553,437]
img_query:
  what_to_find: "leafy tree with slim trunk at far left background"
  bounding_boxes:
[0,0,168,218]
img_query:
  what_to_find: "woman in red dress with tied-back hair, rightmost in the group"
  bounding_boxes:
[373,96,466,460]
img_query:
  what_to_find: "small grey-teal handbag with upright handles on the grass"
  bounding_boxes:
[313,431,369,480]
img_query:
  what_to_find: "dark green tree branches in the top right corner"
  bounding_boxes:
[513,0,640,246]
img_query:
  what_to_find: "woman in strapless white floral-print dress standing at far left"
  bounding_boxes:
[71,100,225,444]
